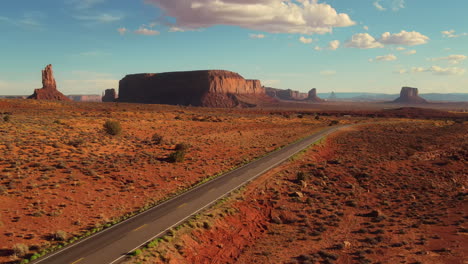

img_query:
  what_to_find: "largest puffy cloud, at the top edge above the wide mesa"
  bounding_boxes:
[146,0,355,34]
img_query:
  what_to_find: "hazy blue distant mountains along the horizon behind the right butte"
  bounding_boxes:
[318,92,468,102]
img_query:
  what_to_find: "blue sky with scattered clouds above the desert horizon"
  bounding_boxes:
[0,0,468,95]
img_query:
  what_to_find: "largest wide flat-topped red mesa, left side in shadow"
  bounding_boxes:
[118,70,265,107]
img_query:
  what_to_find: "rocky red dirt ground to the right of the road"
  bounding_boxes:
[129,122,468,264]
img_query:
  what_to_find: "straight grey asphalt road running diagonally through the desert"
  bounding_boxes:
[33,126,344,264]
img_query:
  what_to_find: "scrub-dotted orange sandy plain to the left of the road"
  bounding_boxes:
[0,100,349,262]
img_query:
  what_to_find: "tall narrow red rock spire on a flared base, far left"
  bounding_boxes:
[28,64,71,101]
